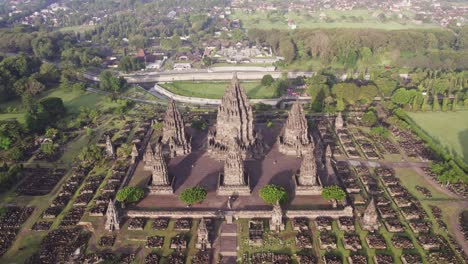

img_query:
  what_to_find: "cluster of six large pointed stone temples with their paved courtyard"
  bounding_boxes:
[137,74,332,202]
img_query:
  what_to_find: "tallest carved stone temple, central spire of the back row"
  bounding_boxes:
[208,73,264,159]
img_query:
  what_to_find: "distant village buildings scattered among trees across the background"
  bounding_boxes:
[1,0,468,71]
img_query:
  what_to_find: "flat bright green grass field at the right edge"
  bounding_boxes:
[408,111,468,163]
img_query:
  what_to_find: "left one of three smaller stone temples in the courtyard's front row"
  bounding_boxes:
[144,144,174,194]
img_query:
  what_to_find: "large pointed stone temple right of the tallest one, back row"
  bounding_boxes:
[278,102,314,157]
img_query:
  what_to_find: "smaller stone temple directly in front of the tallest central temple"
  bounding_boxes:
[217,139,250,196]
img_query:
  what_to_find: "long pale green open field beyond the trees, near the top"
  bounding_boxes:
[232,10,440,30]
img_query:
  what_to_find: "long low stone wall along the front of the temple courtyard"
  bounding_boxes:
[127,206,353,219]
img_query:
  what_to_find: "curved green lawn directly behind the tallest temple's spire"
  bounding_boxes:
[161,82,275,99]
